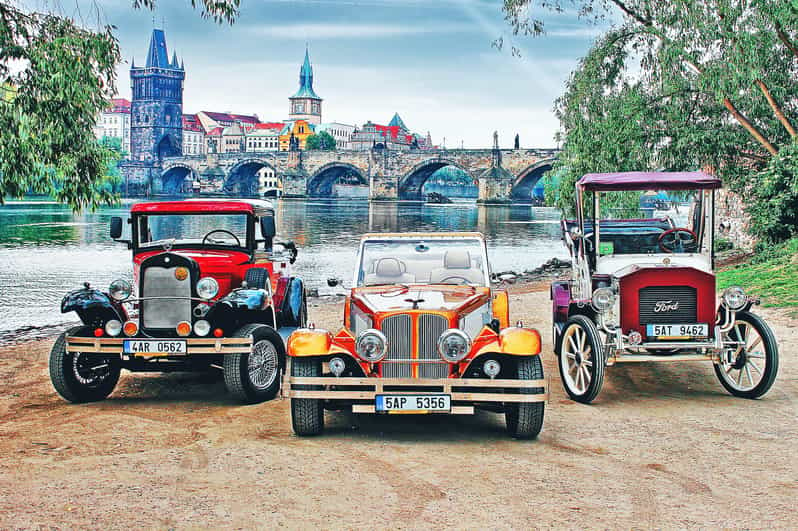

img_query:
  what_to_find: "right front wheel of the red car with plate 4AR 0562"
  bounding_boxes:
[223,324,285,404]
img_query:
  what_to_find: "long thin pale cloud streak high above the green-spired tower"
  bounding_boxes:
[245,23,474,41]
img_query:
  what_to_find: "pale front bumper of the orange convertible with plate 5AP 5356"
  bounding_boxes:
[282,365,549,414]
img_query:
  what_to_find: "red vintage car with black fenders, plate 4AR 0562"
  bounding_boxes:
[50,200,306,402]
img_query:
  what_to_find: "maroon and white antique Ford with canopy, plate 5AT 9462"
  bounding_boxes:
[551,172,779,403]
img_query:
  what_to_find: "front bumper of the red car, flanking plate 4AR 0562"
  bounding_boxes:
[66,336,252,358]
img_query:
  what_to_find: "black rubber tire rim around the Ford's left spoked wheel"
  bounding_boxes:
[557,315,606,404]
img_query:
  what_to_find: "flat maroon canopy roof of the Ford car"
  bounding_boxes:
[576,171,722,192]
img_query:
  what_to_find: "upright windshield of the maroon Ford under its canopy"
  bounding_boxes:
[585,190,710,256]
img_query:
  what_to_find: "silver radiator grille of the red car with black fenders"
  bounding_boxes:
[141,266,191,328]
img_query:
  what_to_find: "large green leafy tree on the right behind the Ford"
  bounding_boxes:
[504,0,798,242]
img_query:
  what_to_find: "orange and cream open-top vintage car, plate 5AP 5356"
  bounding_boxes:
[284,232,547,439]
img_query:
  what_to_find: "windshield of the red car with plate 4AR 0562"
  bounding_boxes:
[135,214,247,247]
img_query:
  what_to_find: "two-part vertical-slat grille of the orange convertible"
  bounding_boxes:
[381,314,449,378]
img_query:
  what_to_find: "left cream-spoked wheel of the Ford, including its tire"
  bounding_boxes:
[558,315,604,404]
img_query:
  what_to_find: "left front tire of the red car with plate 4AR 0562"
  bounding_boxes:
[50,326,122,404]
